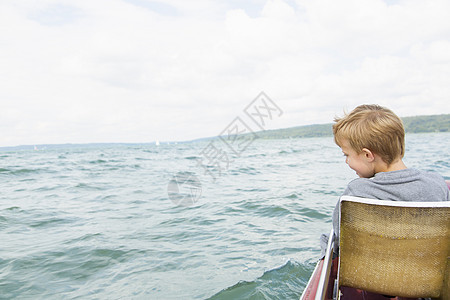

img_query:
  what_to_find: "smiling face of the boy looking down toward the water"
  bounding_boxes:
[341,140,375,178]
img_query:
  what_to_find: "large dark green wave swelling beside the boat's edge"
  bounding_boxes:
[209,260,310,300]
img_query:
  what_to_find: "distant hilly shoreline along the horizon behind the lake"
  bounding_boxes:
[0,114,450,152]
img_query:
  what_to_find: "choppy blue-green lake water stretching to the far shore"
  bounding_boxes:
[0,133,450,299]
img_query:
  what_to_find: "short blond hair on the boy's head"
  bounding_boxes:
[333,104,405,165]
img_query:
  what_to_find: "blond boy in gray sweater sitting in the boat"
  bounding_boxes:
[321,105,450,254]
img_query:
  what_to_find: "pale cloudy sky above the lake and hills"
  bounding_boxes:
[0,0,450,146]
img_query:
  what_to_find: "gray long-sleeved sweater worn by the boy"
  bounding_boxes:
[321,169,450,253]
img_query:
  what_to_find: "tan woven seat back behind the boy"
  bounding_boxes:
[339,199,450,298]
